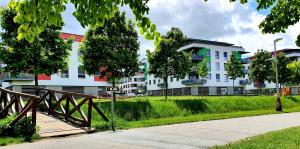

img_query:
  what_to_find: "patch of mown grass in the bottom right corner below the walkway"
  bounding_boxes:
[214,127,300,149]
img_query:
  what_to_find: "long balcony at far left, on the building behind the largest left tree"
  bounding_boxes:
[2,73,34,82]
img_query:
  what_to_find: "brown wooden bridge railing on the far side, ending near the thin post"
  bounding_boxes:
[39,89,109,127]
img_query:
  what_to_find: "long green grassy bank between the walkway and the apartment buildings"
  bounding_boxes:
[74,96,300,130]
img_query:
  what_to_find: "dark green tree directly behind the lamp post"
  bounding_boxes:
[271,52,292,89]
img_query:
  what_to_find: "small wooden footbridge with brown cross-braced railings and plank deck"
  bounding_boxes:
[0,88,109,137]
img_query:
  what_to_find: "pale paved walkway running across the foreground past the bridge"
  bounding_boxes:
[3,113,300,149]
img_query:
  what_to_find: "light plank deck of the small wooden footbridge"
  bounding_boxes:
[37,112,91,138]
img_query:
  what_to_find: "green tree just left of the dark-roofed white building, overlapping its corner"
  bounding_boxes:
[147,27,191,99]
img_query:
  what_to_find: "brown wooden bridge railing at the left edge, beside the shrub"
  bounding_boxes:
[0,88,40,126]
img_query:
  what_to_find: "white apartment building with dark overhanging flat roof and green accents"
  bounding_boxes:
[146,39,248,95]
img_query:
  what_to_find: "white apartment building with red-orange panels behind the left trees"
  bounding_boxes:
[2,33,110,95]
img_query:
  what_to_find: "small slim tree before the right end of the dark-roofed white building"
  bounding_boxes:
[225,54,245,95]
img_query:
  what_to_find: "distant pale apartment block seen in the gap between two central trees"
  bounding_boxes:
[119,59,147,96]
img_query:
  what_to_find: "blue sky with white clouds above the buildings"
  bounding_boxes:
[0,0,300,57]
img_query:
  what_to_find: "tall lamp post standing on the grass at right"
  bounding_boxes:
[274,38,282,111]
